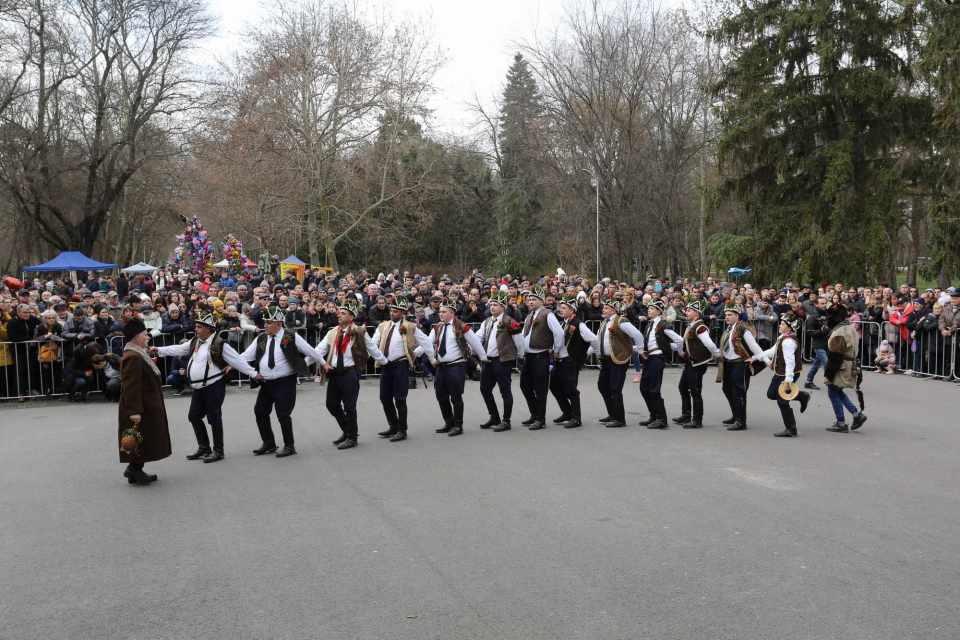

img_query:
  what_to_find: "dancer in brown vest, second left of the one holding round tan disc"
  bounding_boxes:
[673,300,720,429]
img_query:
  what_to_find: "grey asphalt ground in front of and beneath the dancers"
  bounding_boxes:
[0,370,960,640]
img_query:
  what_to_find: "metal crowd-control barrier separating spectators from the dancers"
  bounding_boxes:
[0,318,960,400]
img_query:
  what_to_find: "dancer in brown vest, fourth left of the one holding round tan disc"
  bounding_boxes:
[588,298,643,427]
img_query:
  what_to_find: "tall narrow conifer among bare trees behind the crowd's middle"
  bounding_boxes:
[490,54,544,273]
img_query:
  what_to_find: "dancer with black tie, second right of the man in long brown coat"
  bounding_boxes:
[240,306,323,458]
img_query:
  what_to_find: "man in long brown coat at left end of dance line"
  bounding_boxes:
[117,318,171,484]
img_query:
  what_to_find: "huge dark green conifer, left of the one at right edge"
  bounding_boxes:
[714,0,928,280]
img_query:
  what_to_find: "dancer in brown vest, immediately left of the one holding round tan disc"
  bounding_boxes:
[717,303,763,431]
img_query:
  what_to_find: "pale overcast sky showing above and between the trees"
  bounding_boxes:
[202,0,562,134]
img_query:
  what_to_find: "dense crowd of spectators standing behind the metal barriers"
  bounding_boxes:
[0,269,960,402]
